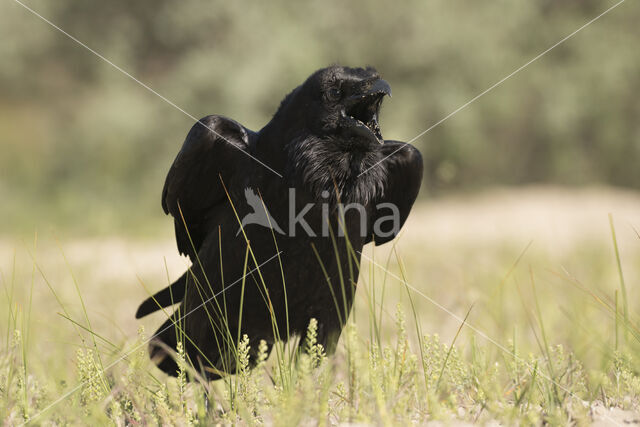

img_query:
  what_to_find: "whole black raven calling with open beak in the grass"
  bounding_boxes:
[136,66,422,379]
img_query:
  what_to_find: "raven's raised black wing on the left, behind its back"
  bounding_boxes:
[162,115,255,260]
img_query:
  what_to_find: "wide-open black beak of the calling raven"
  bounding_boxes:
[342,79,391,144]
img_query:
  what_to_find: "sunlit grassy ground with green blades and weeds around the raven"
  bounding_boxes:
[0,190,640,425]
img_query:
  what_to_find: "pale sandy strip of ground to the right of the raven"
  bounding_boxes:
[403,187,640,250]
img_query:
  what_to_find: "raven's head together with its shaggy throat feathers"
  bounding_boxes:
[256,65,391,203]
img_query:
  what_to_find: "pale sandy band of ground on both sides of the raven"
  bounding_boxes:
[0,187,640,324]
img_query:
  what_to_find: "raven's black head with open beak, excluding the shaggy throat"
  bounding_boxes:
[274,65,391,148]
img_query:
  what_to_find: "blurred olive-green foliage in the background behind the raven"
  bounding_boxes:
[0,0,640,234]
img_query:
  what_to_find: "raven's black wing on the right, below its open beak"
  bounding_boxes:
[367,141,423,245]
